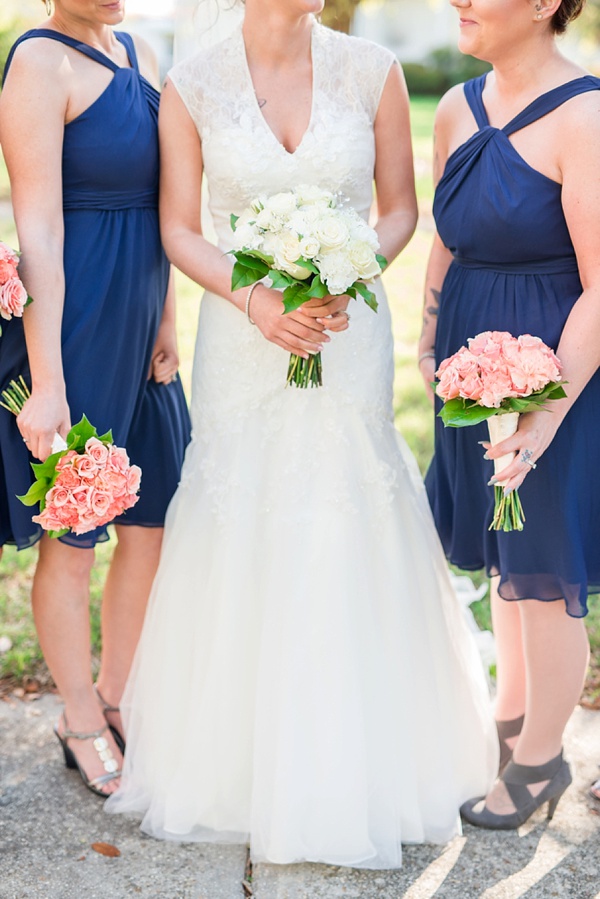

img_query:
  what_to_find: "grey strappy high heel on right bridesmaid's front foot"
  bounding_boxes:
[460,752,573,830]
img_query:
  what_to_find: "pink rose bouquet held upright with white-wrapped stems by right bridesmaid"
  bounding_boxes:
[433,331,566,531]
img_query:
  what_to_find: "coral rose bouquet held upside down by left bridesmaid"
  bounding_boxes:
[0,378,142,537]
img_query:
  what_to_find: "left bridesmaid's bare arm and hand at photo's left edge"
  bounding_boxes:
[0,40,70,459]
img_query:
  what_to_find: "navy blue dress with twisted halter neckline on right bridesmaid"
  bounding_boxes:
[426,75,600,617]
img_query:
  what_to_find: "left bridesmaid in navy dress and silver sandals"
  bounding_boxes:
[0,0,189,796]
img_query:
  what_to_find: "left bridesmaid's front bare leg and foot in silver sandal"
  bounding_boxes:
[32,536,122,794]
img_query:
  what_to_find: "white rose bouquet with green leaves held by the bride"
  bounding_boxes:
[230,186,387,387]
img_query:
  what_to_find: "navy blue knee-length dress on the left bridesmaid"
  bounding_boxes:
[0,28,190,549]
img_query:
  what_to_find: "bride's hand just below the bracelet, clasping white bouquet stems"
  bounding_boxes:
[249,284,337,359]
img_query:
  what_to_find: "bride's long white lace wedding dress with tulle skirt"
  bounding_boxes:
[107,25,497,868]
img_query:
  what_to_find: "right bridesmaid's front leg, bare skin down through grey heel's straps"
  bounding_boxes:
[468,600,589,815]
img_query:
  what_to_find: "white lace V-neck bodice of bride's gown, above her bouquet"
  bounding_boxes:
[169,23,394,249]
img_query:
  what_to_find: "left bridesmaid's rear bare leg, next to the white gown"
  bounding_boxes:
[93,525,163,733]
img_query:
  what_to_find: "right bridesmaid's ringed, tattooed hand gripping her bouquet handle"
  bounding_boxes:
[482,410,562,494]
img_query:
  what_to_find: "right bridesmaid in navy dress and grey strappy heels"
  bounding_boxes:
[419,0,600,829]
